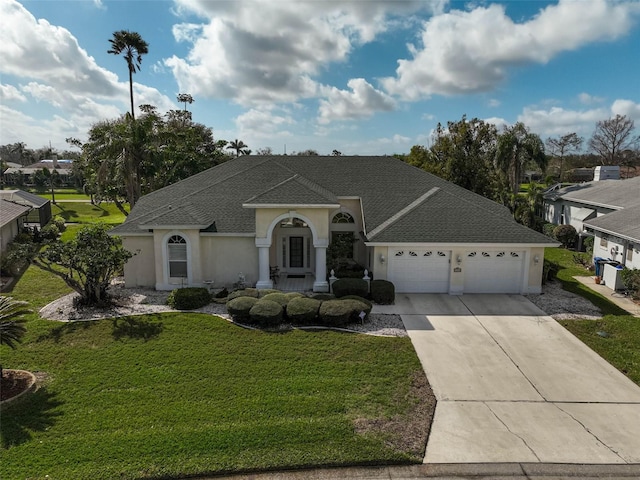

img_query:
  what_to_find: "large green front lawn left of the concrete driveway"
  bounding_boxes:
[0,267,426,479]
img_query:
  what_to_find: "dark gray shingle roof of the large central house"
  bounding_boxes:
[113,155,556,245]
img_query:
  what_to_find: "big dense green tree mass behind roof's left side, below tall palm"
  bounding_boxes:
[67,105,228,215]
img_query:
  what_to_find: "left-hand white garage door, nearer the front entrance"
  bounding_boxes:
[387,249,451,293]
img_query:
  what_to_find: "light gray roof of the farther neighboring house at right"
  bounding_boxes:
[545,177,640,210]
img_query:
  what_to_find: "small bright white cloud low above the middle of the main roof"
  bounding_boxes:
[318,78,395,124]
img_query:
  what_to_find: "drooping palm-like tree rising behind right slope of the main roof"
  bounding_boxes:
[494,122,547,201]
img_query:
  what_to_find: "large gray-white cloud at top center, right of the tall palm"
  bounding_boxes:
[165,0,436,106]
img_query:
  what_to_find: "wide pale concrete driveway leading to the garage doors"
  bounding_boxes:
[374,294,640,464]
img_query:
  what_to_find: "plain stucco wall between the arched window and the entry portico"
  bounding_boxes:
[200,236,258,287]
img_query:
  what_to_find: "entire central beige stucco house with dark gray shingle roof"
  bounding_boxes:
[111,155,558,294]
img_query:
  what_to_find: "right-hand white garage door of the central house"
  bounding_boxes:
[462,250,525,293]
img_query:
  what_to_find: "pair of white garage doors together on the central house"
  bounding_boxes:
[387,247,526,293]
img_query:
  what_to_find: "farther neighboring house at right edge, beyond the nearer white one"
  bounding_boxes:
[544,177,640,233]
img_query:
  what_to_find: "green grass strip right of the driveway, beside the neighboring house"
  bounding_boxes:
[545,248,640,385]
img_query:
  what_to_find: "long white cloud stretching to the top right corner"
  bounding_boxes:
[382,0,640,100]
